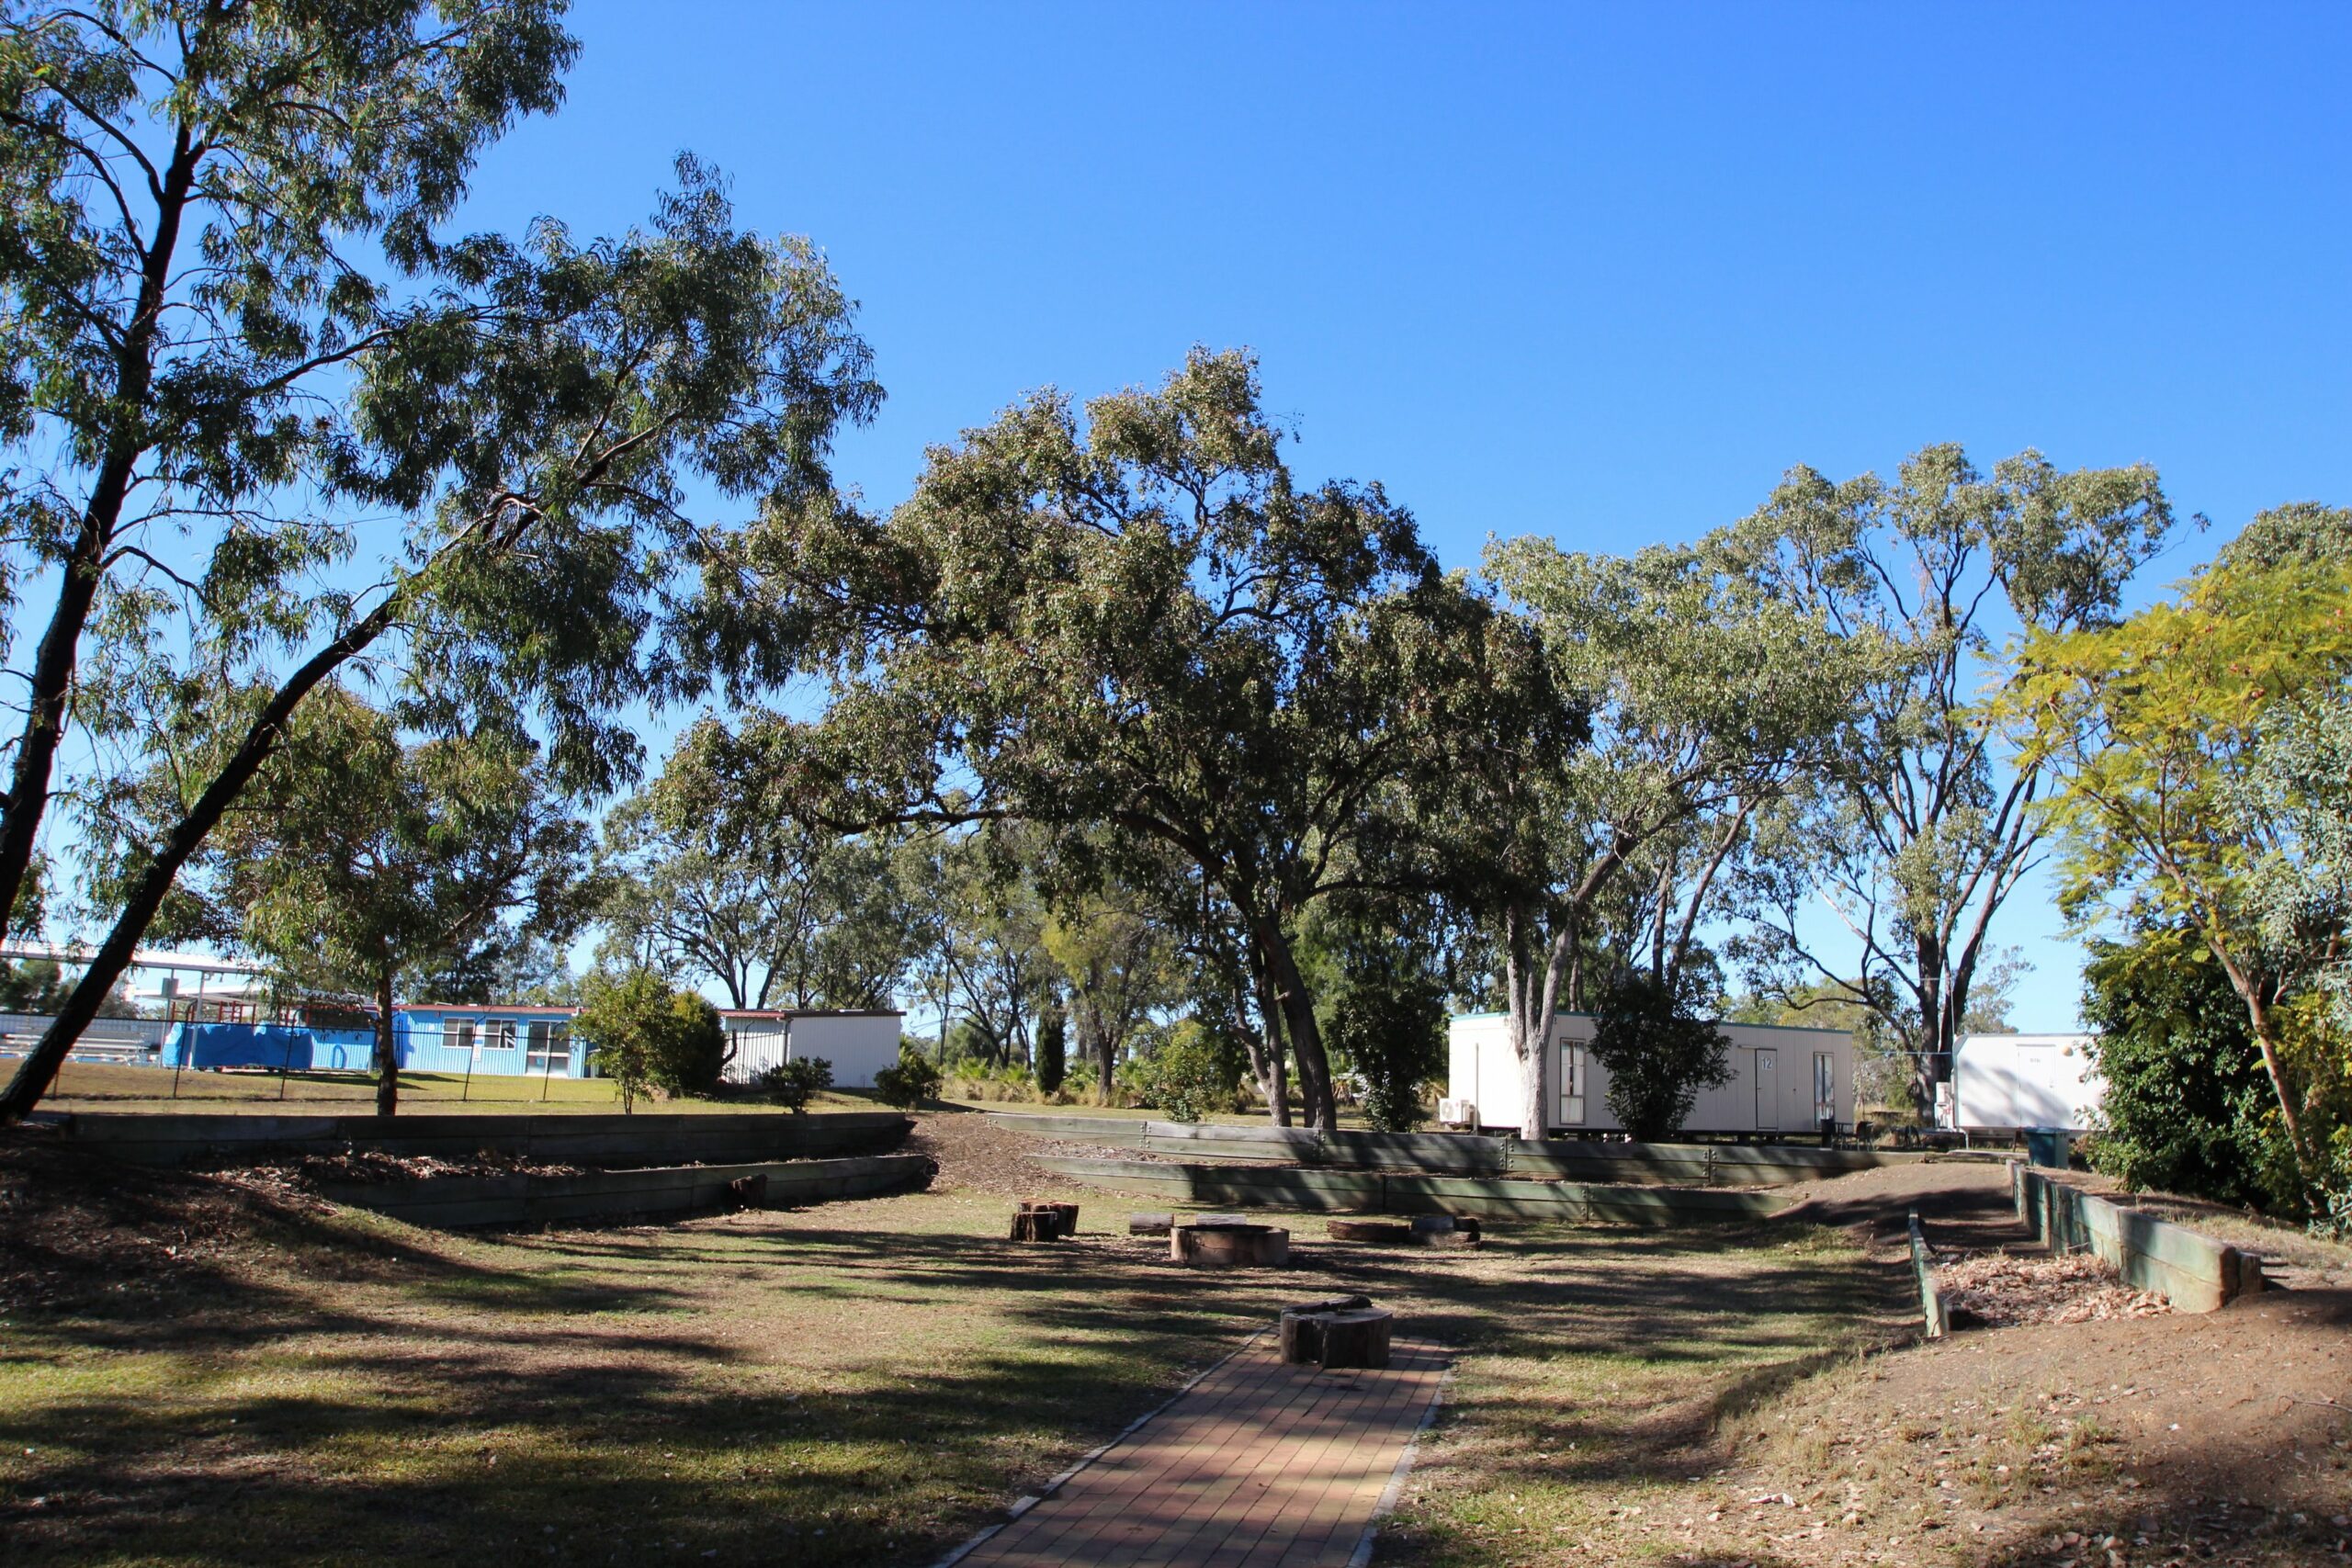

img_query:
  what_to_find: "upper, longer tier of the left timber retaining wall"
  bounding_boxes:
[43,1112,915,1166]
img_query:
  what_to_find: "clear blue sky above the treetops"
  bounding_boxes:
[470,0,2352,1027]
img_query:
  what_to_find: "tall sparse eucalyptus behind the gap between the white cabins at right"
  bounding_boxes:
[1724,445,2173,1107]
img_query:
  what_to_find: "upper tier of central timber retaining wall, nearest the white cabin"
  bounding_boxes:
[988,1112,1924,1187]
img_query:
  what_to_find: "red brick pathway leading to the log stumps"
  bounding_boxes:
[950,1333,1446,1568]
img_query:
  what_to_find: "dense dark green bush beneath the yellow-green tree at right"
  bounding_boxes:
[2082,931,2293,1208]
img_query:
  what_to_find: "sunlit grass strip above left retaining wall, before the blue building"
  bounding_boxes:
[42,1063,882,1117]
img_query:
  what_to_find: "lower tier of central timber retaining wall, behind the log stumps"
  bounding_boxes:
[1035,1159,1788,1224]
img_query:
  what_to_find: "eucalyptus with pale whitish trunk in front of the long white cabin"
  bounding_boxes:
[1442,538,1863,1138]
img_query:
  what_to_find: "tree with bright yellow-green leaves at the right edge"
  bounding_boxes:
[1999,508,2352,1180]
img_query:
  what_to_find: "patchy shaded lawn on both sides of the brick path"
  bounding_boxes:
[0,1166,1865,1565]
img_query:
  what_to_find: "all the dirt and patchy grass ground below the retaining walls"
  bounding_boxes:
[0,1112,2352,1568]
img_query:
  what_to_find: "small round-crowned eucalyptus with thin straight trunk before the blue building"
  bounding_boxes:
[177,684,593,1117]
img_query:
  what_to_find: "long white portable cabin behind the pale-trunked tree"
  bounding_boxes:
[1446,1013,1853,1138]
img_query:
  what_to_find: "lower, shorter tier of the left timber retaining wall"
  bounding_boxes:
[322,1155,933,1229]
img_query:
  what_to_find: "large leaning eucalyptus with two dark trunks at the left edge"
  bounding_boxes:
[0,0,879,1119]
